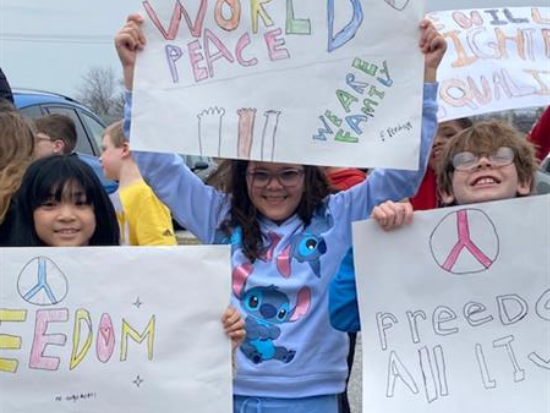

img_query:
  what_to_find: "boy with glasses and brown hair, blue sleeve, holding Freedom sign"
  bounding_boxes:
[330,121,537,331]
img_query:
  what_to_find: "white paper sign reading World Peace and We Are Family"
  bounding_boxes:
[131,0,430,169]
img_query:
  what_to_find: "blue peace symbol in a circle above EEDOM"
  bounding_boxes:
[17,257,69,306]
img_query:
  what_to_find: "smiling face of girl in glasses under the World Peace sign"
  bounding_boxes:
[246,162,304,224]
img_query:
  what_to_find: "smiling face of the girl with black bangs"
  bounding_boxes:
[33,184,96,247]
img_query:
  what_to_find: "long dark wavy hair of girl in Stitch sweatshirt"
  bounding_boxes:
[218,161,334,262]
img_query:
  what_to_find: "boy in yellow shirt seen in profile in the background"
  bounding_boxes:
[99,121,177,245]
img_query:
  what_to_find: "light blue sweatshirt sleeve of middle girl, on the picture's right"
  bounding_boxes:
[330,83,437,222]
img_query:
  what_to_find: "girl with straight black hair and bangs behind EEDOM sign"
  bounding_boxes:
[8,155,120,247]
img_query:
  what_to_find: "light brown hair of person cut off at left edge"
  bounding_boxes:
[0,111,34,224]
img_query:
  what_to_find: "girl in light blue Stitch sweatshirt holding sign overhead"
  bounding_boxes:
[115,15,446,413]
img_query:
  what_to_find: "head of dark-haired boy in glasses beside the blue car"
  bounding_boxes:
[35,113,76,158]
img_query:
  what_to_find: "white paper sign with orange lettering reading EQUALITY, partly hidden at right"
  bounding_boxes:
[429,7,550,121]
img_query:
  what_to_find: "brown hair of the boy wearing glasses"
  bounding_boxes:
[437,120,538,200]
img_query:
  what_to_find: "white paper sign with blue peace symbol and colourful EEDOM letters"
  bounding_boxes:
[0,246,232,413]
